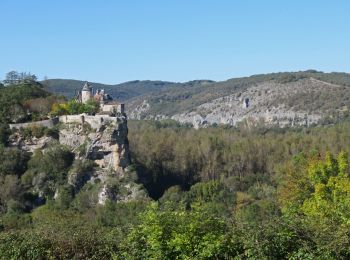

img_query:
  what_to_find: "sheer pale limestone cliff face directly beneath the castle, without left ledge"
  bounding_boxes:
[59,115,130,204]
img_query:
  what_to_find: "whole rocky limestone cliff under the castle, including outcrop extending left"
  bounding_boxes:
[9,114,147,204]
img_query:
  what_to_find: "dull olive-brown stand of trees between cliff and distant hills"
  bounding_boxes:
[129,121,350,198]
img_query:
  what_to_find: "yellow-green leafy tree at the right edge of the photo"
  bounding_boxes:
[283,152,350,259]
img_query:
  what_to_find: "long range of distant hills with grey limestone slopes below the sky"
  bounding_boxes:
[46,70,350,126]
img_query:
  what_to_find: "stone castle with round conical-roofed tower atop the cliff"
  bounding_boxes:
[77,82,125,114]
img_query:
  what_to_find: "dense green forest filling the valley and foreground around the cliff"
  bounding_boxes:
[0,117,350,259]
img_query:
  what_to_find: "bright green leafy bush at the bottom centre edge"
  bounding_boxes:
[123,204,237,259]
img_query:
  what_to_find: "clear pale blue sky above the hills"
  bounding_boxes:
[0,0,350,83]
